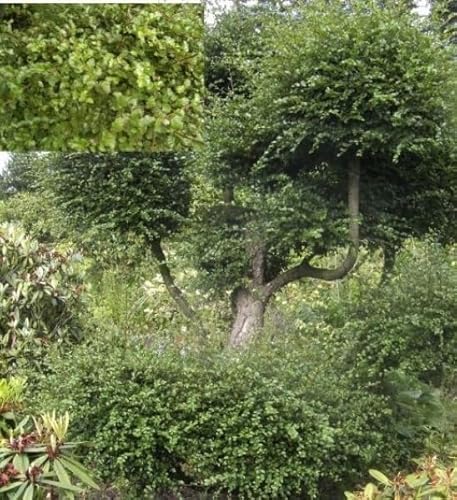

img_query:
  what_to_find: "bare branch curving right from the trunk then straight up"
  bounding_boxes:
[265,158,360,298]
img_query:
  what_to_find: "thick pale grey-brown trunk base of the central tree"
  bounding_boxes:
[229,288,266,347]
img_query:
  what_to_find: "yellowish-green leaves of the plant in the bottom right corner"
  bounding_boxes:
[346,456,457,500]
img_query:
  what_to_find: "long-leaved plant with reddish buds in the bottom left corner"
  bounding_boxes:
[0,412,98,500]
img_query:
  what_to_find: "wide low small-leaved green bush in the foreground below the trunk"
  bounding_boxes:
[30,338,420,498]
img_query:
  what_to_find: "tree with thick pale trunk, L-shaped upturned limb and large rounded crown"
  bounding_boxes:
[200,1,456,345]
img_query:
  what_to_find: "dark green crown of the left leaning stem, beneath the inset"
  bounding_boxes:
[42,153,189,243]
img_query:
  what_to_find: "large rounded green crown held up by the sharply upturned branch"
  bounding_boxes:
[204,1,455,274]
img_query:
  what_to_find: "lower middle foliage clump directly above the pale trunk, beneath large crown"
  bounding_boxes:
[186,175,347,293]
